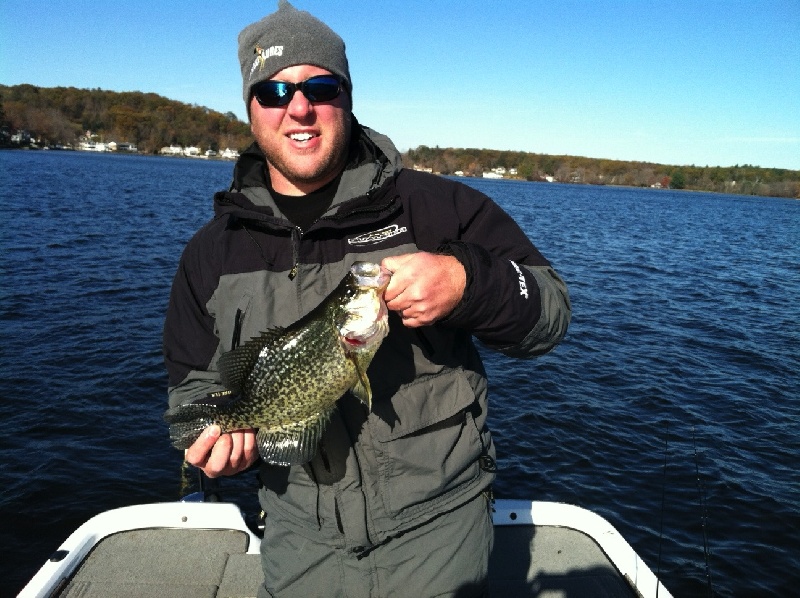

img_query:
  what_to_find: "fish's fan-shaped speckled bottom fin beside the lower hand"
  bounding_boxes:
[256,408,333,465]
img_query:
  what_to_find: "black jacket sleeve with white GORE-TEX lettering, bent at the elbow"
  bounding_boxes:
[409,175,571,357]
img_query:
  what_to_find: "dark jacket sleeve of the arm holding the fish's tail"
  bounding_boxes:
[163,229,224,407]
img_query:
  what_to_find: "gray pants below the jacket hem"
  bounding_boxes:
[258,494,494,598]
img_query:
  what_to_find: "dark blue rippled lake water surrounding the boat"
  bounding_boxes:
[0,151,800,596]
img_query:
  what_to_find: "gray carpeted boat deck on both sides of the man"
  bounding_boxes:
[51,526,636,598]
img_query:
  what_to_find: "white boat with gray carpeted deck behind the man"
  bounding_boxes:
[19,493,671,598]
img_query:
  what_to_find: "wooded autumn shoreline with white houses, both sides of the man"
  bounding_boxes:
[0,84,800,198]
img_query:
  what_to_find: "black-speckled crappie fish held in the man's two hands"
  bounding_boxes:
[164,262,390,465]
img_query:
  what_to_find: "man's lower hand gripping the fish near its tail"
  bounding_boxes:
[185,426,258,478]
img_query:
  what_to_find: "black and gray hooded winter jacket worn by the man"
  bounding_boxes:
[164,124,570,551]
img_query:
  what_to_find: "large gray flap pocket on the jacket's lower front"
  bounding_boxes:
[368,370,484,516]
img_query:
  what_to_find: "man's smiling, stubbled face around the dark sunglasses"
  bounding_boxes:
[250,65,351,195]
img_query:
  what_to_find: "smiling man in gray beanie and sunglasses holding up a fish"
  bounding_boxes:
[164,1,570,596]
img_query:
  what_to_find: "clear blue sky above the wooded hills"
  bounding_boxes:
[0,0,800,170]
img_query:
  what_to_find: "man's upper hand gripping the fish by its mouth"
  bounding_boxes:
[381,251,467,328]
